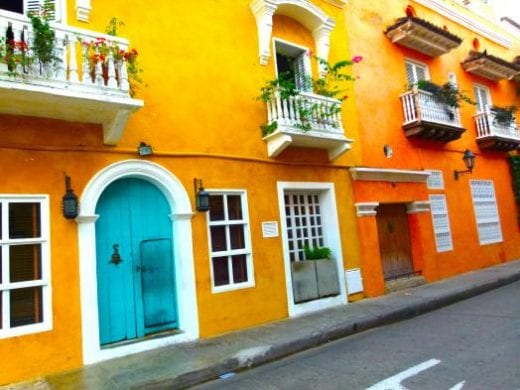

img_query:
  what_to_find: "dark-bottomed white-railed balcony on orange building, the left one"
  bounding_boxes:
[401,89,466,142]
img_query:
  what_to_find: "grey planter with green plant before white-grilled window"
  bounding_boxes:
[291,259,339,303]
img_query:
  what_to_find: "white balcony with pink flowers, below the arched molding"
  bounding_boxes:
[263,92,353,161]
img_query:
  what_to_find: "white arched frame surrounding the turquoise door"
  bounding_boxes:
[76,160,199,364]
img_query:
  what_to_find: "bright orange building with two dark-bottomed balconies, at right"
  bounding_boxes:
[346,0,520,296]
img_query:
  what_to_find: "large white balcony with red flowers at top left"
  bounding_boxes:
[0,11,143,145]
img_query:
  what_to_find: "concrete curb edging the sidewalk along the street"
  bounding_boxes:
[140,264,520,389]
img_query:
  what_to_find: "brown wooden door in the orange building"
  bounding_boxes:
[376,204,414,280]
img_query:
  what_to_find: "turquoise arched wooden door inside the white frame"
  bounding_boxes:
[96,179,177,344]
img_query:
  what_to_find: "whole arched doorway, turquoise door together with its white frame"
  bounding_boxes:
[76,160,199,364]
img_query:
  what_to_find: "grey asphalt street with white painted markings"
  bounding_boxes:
[196,282,520,390]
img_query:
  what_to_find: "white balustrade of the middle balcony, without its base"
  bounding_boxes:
[267,92,343,135]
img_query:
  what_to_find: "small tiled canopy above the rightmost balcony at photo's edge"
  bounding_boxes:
[462,50,520,81]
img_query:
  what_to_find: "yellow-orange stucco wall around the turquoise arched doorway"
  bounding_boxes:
[0,0,360,384]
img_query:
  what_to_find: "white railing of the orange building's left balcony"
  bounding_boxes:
[401,89,460,127]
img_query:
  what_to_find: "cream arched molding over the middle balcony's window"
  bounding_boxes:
[249,0,336,68]
